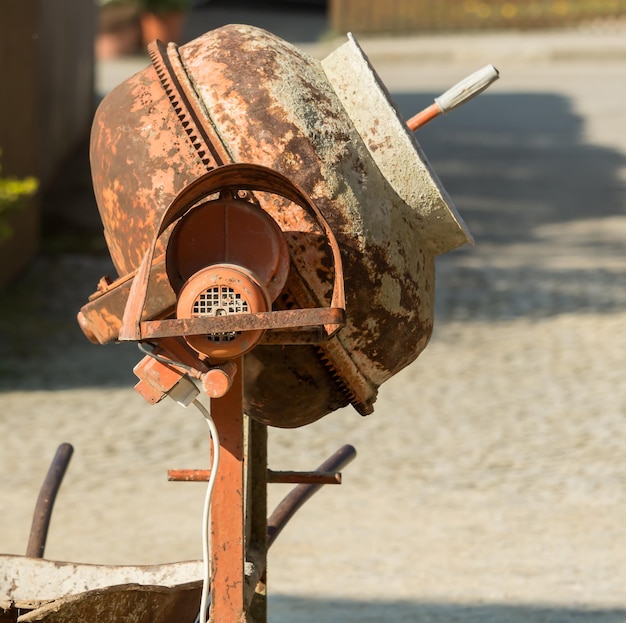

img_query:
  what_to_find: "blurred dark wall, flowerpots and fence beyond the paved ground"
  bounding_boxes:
[0,0,626,284]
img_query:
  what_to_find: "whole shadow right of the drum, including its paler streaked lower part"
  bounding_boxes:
[393,93,626,320]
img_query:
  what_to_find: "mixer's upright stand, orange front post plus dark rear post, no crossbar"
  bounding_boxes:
[209,357,267,623]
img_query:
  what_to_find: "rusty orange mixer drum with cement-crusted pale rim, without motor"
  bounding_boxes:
[81,25,470,427]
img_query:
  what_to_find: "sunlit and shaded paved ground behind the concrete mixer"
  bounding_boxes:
[0,3,626,623]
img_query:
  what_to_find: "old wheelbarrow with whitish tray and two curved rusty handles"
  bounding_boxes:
[0,443,356,623]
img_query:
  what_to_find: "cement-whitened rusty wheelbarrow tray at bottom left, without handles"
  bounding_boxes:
[0,555,202,623]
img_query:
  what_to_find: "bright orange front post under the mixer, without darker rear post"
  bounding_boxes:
[209,357,247,623]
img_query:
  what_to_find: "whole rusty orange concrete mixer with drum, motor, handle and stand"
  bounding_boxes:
[70,25,497,623]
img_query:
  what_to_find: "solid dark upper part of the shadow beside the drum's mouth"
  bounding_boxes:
[392,93,626,247]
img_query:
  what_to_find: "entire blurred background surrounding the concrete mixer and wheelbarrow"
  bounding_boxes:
[0,0,626,623]
